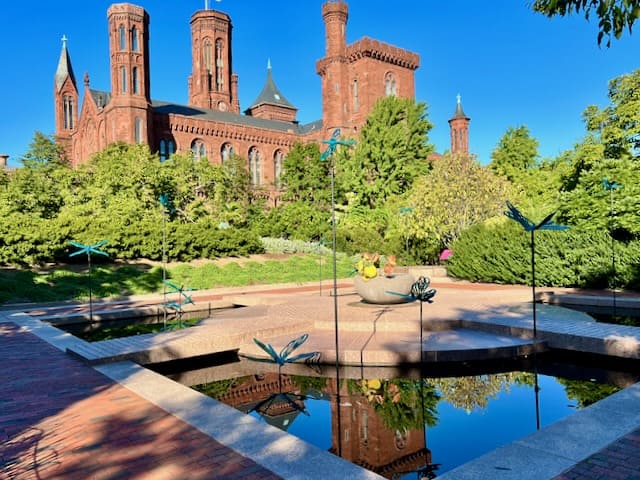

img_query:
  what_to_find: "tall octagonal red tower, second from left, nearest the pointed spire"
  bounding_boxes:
[106,3,152,144]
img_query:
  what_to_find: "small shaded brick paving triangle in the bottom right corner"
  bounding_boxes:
[554,429,640,480]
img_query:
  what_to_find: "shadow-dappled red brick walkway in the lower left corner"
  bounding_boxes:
[0,323,281,480]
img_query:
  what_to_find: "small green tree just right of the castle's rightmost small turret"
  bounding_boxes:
[489,125,538,181]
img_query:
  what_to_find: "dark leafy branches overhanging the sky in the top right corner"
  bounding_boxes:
[532,0,640,47]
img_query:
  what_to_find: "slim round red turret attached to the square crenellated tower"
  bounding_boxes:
[316,1,350,132]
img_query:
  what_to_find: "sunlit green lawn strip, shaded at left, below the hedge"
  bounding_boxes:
[0,255,353,304]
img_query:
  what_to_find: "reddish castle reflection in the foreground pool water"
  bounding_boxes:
[208,372,435,479]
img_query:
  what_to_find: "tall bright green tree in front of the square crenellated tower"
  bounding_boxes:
[337,96,433,208]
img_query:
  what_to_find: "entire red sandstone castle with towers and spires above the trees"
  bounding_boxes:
[54,1,469,186]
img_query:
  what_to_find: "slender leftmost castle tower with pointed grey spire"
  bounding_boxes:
[53,36,78,158]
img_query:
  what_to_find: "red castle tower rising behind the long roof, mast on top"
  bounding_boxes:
[189,6,240,113]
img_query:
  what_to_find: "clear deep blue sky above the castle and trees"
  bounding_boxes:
[0,0,640,165]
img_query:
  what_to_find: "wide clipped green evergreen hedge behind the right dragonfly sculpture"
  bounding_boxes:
[447,221,640,288]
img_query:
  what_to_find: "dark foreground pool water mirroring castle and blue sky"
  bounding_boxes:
[152,356,638,479]
